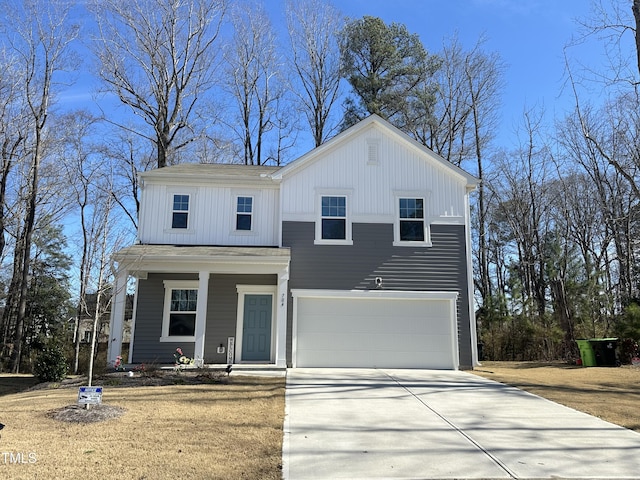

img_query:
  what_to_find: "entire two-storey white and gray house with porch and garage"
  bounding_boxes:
[109,115,478,369]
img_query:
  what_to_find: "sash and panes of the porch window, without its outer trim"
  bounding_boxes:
[163,288,198,338]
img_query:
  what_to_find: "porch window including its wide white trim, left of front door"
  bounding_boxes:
[160,280,198,342]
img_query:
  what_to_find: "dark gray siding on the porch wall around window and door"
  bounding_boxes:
[133,273,276,364]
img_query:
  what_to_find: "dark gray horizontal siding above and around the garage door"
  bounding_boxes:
[282,222,471,368]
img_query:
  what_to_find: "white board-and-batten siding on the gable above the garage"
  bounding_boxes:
[282,125,467,224]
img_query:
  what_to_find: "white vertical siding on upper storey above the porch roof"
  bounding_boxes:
[138,183,279,246]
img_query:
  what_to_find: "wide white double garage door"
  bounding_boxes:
[292,290,458,369]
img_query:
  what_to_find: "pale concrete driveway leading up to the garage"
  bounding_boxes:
[283,369,640,480]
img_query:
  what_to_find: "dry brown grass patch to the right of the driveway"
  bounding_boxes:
[473,362,640,432]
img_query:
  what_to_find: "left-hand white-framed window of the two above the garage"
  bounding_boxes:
[314,191,353,245]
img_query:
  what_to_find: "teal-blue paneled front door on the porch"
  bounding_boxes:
[242,295,273,362]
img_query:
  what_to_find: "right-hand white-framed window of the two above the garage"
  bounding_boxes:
[394,196,431,246]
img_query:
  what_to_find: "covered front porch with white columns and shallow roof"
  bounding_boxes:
[108,245,290,368]
